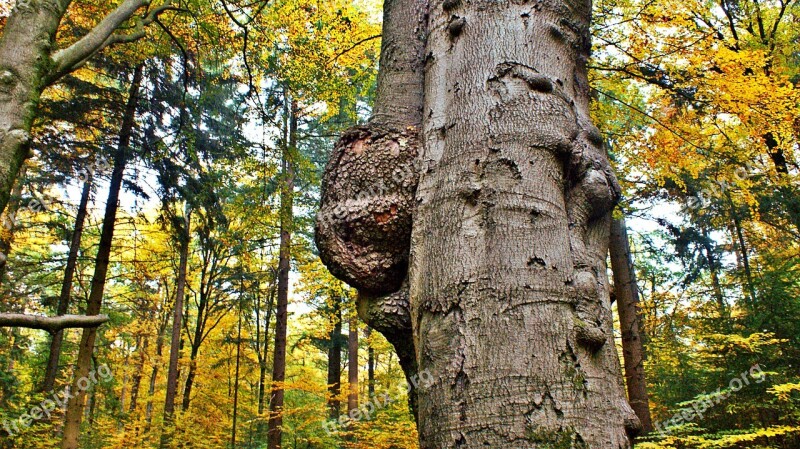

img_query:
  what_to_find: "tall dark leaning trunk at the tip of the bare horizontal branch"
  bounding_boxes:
[62,64,144,449]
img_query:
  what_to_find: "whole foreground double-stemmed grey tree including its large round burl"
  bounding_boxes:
[316,0,641,449]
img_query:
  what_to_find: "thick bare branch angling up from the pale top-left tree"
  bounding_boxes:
[47,0,175,84]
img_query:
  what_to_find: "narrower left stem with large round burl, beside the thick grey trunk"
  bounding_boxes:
[315,0,428,409]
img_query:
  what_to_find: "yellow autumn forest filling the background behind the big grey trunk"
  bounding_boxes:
[0,0,800,449]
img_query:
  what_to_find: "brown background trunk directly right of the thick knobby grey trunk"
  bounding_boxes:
[609,219,653,432]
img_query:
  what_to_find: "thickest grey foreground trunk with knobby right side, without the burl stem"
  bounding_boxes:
[409,0,640,449]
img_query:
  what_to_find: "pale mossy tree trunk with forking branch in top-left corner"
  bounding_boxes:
[0,0,171,217]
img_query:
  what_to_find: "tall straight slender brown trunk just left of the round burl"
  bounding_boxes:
[267,97,298,449]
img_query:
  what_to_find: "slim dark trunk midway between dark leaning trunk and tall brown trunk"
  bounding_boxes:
[160,204,192,449]
